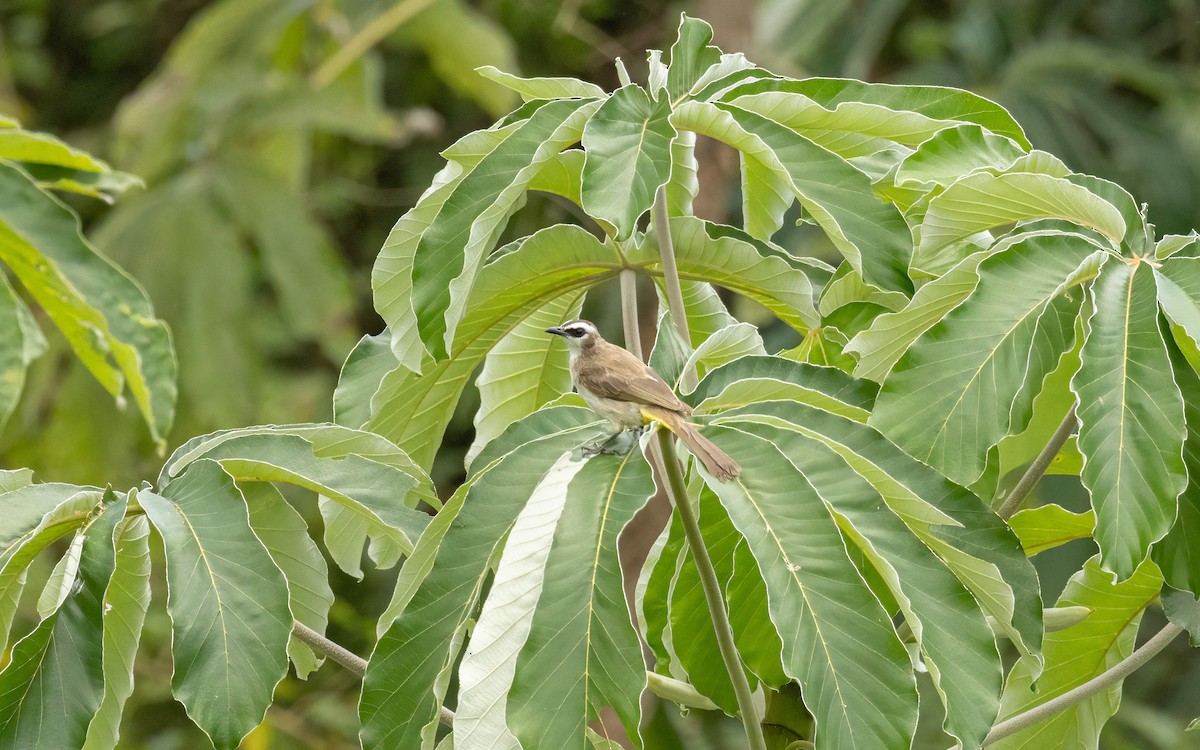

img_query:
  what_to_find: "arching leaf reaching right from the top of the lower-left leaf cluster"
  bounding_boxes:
[160,425,437,577]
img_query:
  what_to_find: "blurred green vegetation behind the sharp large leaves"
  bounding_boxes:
[0,0,1200,748]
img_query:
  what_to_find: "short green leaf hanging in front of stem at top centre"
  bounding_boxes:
[582,86,676,240]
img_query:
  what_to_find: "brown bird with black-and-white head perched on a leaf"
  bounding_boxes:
[546,320,742,481]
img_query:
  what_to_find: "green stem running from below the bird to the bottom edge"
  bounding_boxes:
[658,426,767,750]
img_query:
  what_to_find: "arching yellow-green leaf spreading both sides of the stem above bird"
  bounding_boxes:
[360,217,816,467]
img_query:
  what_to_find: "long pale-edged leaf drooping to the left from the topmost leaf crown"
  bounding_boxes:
[373,100,599,365]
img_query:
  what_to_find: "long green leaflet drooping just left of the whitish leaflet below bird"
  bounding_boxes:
[359,407,606,750]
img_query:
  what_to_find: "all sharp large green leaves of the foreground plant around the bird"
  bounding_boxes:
[0,17,1200,749]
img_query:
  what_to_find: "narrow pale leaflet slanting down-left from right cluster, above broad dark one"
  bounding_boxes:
[842,252,990,383]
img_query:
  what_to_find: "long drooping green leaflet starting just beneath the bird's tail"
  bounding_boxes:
[709,428,917,748]
